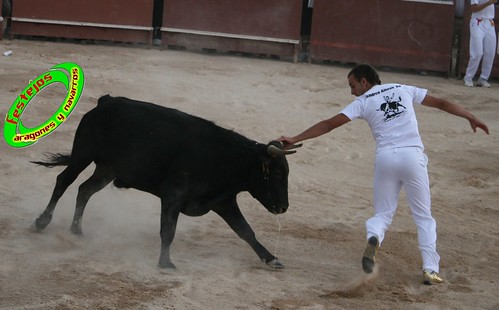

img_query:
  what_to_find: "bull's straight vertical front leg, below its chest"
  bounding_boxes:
[158,198,180,268]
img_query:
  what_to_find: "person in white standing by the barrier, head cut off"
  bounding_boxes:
[464,0,497,87]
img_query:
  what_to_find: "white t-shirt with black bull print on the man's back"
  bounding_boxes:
[340,84,428,152]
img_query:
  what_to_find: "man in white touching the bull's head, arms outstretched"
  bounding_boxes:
[278,65,489,284]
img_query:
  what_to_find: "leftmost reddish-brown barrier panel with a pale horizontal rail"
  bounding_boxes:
[11,0,154,44]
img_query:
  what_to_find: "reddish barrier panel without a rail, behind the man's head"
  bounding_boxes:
[310,0,455,74]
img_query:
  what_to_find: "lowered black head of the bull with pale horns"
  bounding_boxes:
[250,141,301,214]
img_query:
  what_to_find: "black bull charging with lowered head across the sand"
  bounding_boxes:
[33,95,295,268]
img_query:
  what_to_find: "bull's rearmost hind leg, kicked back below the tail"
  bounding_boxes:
[33,162,90,230]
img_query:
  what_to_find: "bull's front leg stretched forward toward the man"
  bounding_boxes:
[213,198,284,269]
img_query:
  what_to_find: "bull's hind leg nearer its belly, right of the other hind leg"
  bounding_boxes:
[70,165,115,235]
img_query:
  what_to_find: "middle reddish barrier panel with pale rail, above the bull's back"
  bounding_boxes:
[161,0,302,62]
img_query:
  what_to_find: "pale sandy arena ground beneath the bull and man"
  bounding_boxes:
[0,40,499,310]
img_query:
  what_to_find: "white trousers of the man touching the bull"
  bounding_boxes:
[366,147,440,272]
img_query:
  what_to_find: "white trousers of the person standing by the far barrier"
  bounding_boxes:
[464,18,497,81]
